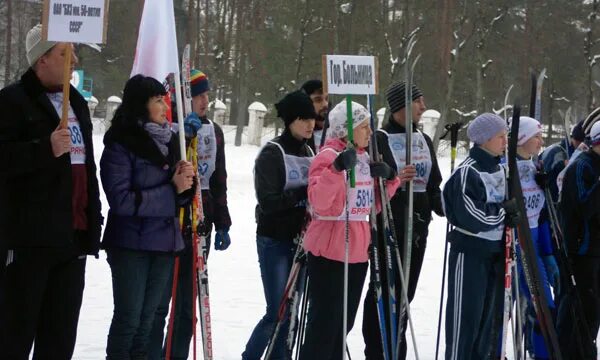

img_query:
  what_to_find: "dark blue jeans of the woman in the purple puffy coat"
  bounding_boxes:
[106,248,174,360]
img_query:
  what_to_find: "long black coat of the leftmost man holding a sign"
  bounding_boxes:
[0,69,103,254]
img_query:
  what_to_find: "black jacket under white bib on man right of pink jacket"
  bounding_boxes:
[377,119,444,245]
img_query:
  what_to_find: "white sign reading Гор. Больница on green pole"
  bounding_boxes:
[323,55,378,95]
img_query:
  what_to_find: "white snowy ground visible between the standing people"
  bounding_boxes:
[74,130,488,360]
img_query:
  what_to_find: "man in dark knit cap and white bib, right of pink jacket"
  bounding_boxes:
[363,82,443,360]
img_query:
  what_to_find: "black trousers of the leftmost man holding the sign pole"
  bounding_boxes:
[0,243,86,360]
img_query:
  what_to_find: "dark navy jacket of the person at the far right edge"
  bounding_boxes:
[559,150,600,256]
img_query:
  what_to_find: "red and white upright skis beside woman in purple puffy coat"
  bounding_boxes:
[166,44,213,360]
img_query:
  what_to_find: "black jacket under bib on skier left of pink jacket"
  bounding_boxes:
[254,130,311,241]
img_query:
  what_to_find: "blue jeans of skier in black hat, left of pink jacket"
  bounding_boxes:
[242,235,296,360]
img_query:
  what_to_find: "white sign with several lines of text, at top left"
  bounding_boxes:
[42,0,108,44]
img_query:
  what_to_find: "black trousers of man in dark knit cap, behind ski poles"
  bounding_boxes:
[362,228,427,360]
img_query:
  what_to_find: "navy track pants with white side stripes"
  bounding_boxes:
[446,246,504,360]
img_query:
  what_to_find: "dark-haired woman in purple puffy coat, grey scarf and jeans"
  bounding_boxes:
[100,75,194,359]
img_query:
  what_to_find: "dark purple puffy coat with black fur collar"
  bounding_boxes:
[100,126,192,252]
